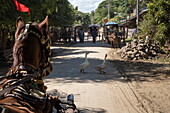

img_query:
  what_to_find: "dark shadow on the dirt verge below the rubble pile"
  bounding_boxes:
[111,60,170,82]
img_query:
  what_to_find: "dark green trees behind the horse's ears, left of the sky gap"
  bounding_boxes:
[0,0,90,51]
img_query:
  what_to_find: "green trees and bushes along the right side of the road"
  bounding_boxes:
[91,0,170,56]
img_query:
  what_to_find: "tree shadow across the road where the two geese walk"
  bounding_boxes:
[46,58,126,83]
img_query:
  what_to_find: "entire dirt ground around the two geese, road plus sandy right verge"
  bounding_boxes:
[0,37,170,113]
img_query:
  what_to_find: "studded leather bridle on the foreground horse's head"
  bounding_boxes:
[8,23,51,78]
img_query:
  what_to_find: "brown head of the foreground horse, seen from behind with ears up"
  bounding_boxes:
[8,16,52,76]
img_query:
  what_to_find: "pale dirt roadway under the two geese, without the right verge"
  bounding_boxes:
[45,41,153,113]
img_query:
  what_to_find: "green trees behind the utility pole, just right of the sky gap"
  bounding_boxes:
[93,0,135,24]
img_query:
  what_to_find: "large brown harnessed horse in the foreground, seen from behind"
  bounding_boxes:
[0,17,57,113]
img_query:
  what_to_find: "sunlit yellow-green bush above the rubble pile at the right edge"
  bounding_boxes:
[139,0,170,45]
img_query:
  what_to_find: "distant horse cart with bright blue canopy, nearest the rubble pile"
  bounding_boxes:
[104,22,125,48]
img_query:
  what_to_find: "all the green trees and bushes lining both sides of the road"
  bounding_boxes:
[0,0,170,53]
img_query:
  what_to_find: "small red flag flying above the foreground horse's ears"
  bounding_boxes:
[14,0,30,15]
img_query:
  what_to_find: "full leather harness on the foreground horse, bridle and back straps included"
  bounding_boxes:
[0,23,50,108]
